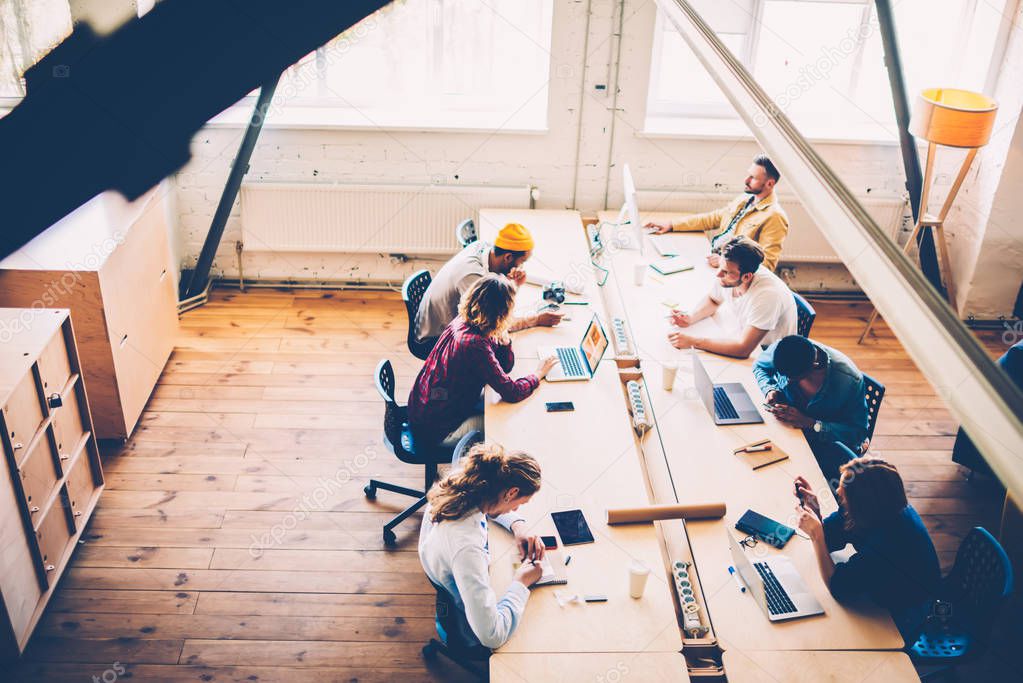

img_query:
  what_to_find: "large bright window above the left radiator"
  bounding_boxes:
[228,0,553,130]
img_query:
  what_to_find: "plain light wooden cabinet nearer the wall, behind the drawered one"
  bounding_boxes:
[0,184,178,437]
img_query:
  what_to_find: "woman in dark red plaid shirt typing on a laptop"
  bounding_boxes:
[408,273,558,449]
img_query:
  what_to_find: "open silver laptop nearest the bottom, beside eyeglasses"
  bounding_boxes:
[725,531,825,622]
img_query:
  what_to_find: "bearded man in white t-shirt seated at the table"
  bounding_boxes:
[668,235,798,358]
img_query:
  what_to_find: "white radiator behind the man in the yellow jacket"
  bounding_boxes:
[636,190,907,263]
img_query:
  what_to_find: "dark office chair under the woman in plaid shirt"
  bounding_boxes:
[362,359,451,547]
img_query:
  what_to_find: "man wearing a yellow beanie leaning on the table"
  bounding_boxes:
[415,223,562,342]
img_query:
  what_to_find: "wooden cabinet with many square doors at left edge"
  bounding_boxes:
[0,309,103,658]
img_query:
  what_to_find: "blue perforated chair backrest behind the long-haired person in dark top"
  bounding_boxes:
[942,527,1013,636]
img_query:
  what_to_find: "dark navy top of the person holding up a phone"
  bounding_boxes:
[824,505,941,637]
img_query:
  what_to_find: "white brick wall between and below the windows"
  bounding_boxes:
[177,0,903,286]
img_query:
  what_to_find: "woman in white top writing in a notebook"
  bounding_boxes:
[419,444,543,649]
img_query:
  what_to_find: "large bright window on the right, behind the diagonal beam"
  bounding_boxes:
[647,0,1006,140]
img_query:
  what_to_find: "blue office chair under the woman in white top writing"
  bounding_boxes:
[422,430,490,680]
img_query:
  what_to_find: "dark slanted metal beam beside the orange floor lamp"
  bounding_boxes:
[875,0,944,294]
